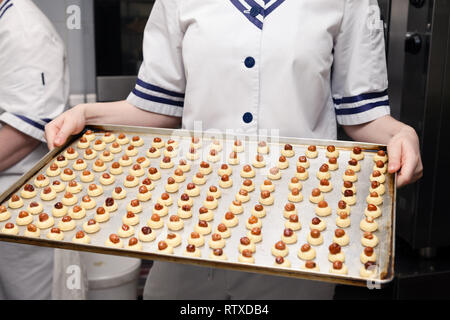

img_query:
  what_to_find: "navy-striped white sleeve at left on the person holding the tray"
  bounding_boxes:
[127,0,186,117]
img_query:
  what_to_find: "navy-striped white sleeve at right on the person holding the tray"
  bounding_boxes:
[331,0,390,125]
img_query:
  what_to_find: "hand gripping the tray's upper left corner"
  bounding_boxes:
[45,104,86,150]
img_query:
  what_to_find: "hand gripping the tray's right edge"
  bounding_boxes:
[388,126,423,187]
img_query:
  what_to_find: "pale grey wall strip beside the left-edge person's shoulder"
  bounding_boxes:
[33,0,96,106]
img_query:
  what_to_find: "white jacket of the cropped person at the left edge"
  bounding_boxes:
[0,0,69,178]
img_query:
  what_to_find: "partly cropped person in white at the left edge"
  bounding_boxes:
[0,0,74,299]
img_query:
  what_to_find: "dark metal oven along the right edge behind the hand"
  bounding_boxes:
[388,0,450,254]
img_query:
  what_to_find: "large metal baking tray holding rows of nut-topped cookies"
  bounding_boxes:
[0,125,396,286]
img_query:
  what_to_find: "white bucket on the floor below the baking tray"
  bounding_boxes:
[82,252,141,300]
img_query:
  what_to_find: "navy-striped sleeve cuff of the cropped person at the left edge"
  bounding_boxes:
[0,112,46,142]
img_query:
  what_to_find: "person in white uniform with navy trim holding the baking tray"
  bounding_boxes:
[46,0,422,299]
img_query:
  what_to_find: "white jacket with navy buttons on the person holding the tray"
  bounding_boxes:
[128,0,390,139]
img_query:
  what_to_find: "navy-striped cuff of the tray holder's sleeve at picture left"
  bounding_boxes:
[127,78,184,117]
